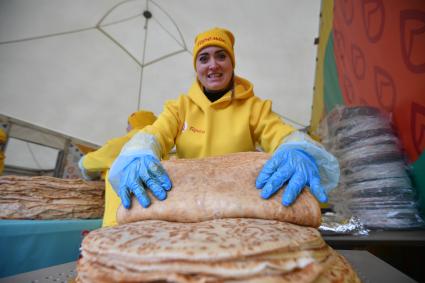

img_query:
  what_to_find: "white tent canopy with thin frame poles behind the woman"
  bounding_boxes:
[0,0,320,171]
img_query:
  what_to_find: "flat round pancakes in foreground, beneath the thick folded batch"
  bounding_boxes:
[77,218,357,282]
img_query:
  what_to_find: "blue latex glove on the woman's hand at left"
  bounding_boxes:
[118,154,171,209]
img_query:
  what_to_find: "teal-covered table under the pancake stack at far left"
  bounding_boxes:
[0,219,102,278]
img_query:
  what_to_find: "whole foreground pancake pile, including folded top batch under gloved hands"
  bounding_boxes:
[77,153,359,282]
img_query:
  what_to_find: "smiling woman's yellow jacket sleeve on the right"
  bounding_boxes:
[251,98,295,153]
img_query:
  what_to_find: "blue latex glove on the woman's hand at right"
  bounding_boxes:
[255,149,328,206]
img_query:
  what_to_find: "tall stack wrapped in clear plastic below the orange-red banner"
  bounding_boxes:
[318,106,424,229]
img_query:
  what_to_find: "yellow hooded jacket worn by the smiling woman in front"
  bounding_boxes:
[141,76,295,158]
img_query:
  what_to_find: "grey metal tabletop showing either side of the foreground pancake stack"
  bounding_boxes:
[0,250,415,283]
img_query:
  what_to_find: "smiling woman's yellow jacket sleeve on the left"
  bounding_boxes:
[141,96,183,158]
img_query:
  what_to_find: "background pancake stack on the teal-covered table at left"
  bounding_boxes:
[0,175,105,219]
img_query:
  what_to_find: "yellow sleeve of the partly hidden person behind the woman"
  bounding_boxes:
[83,130,137,172]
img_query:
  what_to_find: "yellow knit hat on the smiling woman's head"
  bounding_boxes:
[193,28,235,70]
